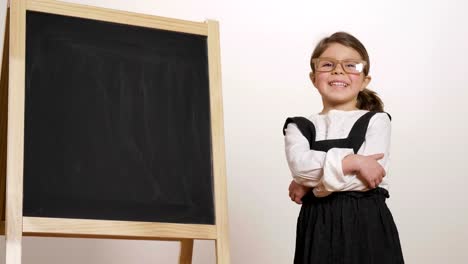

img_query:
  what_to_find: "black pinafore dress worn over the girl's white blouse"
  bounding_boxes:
[283,112,404,264]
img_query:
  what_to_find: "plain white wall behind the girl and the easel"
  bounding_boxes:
[0,0,468,264]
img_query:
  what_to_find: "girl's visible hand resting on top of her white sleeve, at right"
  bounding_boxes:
[343,153,385,189]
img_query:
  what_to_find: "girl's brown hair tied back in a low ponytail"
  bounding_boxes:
[310,32,384,112]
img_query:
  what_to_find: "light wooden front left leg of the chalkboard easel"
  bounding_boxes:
[5,0,26,264]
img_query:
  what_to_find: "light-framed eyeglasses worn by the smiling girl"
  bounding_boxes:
[312,58,367,74]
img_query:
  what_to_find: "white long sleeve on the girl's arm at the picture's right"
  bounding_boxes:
[317,113,391,192]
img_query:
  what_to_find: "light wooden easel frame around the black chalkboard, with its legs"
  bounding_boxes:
[0,0,229,264]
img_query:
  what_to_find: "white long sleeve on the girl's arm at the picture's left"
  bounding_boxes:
[284,123,326,187]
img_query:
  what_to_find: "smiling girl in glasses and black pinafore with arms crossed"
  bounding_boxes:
[283,32,404,264]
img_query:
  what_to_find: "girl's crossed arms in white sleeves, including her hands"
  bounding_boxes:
[285,113,391,203]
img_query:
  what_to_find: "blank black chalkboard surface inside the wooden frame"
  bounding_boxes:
[23,11,215,224]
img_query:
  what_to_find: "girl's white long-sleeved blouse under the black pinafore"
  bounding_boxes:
[284,110,391,197]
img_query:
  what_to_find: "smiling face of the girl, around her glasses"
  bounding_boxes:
[310,43,371,109]
